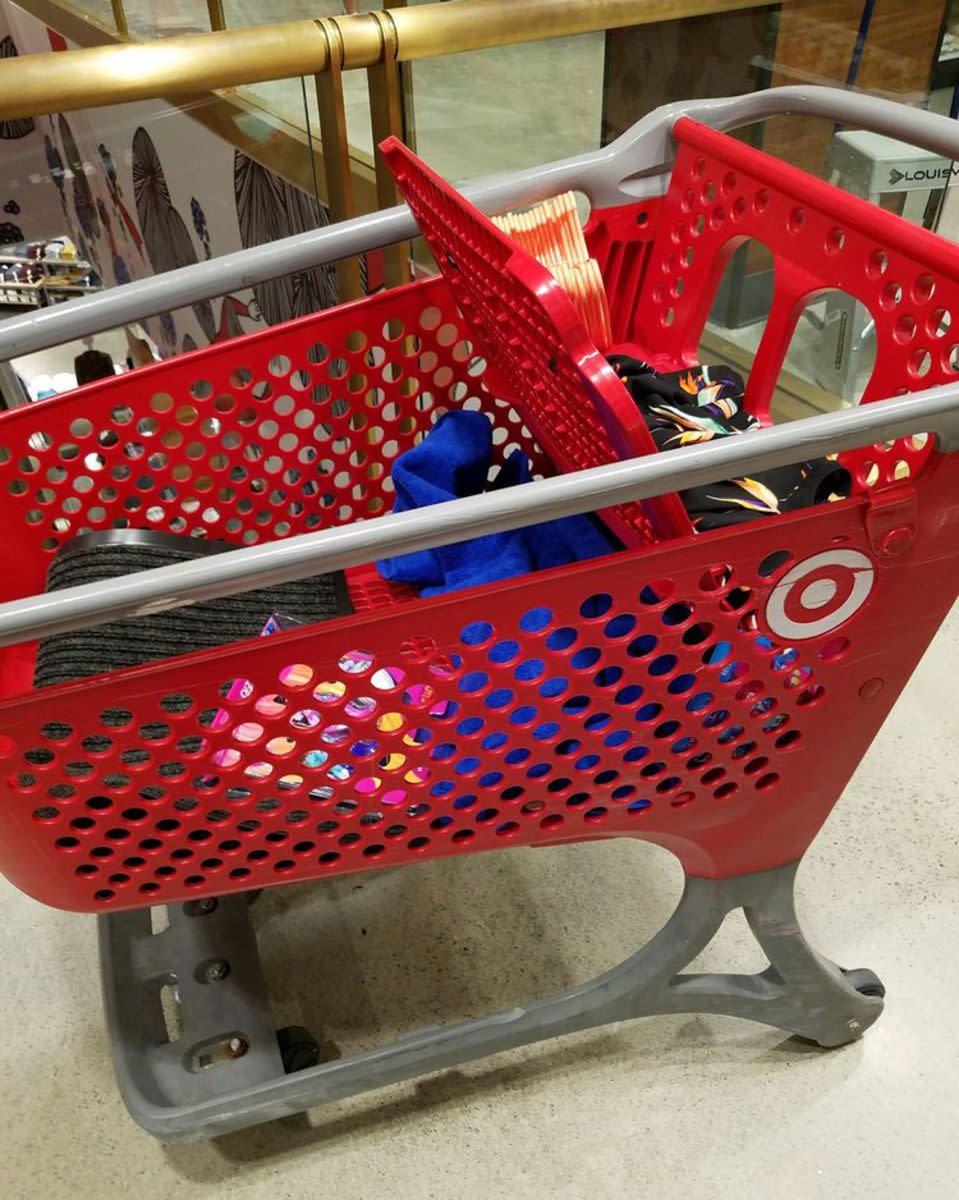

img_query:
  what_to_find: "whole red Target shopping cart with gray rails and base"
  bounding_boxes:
[0,89,959,1139]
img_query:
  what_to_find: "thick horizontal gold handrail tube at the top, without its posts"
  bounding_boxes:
[0,0,769,119]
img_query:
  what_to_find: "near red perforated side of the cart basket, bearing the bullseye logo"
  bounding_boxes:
[0,458,959,908]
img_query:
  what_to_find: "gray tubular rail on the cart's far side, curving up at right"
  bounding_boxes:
[0,86,959,361]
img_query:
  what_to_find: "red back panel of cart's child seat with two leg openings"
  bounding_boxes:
[628,118,959,490]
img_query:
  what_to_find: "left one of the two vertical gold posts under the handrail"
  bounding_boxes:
[307,18,362,301]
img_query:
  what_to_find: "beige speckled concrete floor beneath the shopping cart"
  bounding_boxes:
[0,611,959,1200]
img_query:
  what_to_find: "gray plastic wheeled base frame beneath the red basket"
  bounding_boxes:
[100,863,883,1141]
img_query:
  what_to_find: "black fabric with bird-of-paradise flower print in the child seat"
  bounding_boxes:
[610,354,852,532]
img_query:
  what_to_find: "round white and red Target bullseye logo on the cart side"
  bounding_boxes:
[766,550,876,642]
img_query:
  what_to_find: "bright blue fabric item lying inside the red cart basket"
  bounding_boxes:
[377,410,621,595]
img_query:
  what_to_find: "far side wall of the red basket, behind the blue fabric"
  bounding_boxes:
[0,280,552,596]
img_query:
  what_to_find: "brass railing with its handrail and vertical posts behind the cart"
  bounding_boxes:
[0,0,769,299]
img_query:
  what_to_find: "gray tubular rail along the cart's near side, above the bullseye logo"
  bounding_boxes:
[0,386,959,646]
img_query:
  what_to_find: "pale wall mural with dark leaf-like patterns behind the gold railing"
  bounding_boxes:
[0,0,345,355]
